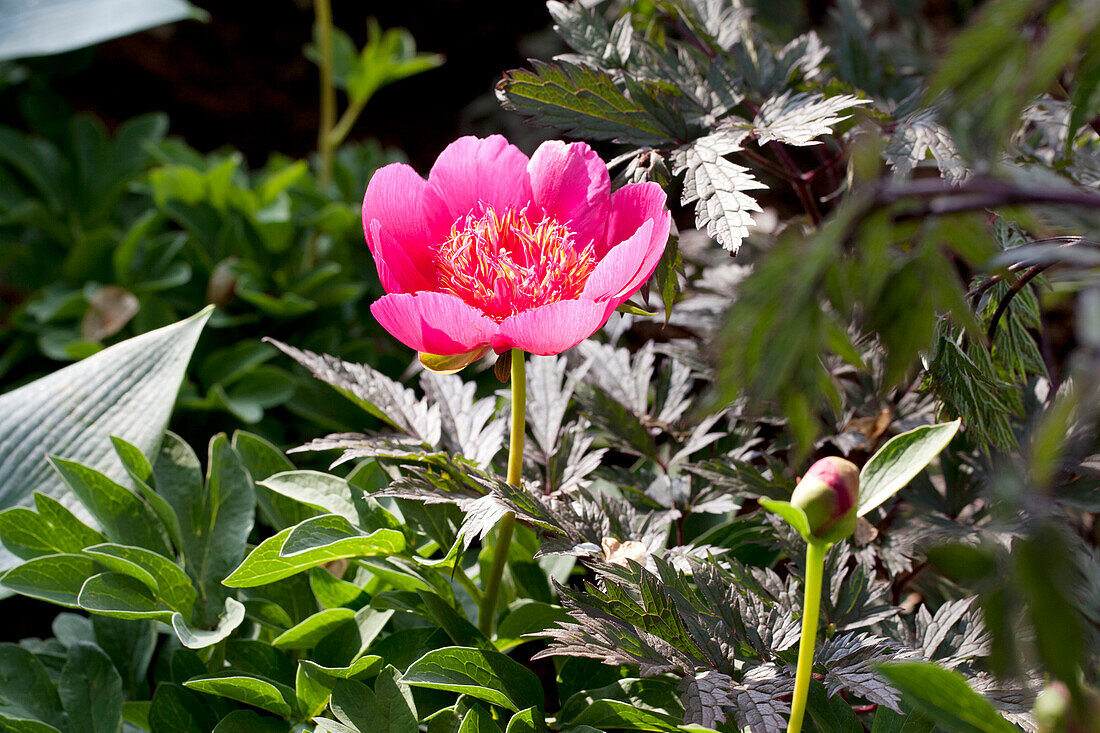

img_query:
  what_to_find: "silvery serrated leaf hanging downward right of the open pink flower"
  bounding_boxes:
[672,132,767,254]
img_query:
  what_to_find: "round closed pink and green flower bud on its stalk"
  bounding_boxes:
[791,456,859,543]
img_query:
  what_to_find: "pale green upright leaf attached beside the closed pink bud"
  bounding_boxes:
[856,420,961,516]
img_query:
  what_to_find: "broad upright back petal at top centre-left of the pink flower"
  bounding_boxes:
[427,135,531,231]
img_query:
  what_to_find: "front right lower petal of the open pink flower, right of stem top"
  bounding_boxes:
[492,299,611,357]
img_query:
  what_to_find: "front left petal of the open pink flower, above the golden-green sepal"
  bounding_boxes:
[371,292,497,355]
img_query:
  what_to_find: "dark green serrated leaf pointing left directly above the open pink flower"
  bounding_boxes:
[497,61,685,146]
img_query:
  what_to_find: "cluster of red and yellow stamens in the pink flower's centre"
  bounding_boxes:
[436,208,596,320]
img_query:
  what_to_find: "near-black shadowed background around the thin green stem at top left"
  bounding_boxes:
[44,0,561,171]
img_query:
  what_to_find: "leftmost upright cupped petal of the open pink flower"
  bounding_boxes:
[363,163,436,266]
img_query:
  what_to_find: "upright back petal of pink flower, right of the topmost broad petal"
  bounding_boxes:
[527,140,612,247]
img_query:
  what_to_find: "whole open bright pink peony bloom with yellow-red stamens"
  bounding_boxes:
[363,135,671,363]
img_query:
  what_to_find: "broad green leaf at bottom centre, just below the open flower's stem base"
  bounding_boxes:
[404,646,542,712]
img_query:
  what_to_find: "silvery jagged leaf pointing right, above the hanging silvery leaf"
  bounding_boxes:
[752,91,870,145]
